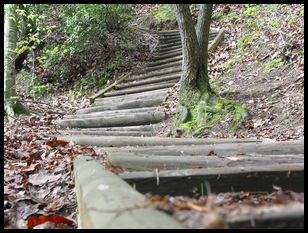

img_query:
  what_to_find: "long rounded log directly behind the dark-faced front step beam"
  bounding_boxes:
[107,153,304,171]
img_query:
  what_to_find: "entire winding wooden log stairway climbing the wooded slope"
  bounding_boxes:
[57,29,304,228]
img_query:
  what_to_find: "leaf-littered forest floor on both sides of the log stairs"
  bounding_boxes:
[4,5,304,228]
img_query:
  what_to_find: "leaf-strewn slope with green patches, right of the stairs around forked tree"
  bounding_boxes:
[160,5,304,140]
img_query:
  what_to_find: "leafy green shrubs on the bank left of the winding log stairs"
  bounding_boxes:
[18,4,139,96]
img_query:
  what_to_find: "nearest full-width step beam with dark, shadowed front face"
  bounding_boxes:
[120,163,304,196]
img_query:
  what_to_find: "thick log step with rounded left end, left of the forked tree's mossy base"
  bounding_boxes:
[56,111,165,128]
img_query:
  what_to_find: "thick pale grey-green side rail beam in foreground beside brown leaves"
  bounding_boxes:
[74,156,183,229]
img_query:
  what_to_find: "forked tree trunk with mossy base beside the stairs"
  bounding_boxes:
[174,4,213,122]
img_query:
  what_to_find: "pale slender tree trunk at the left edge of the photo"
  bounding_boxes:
[4,4,27,120]
